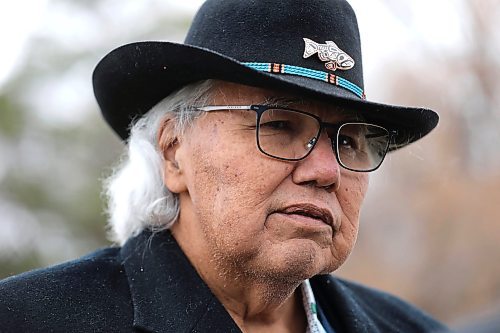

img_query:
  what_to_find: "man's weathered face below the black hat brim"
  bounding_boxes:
[164,83,368,281]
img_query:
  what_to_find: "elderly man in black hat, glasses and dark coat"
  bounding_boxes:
[0,0,444,332]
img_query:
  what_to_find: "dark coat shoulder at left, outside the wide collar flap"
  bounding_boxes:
[0,248,132,332]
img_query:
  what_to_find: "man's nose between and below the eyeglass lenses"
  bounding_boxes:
[292,133,341,191]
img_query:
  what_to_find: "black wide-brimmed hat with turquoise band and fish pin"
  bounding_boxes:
[93,0,439,149]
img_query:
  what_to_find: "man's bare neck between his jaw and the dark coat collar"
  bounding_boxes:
[171,219,307,332]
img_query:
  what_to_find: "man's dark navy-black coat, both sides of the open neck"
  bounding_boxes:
[0,231,443,333]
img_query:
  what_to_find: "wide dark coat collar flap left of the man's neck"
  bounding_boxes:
[120,231,240,332]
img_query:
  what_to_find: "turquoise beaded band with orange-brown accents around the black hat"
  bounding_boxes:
[243,62,366,99]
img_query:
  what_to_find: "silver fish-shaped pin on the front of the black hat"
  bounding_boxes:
[304,38,355,71]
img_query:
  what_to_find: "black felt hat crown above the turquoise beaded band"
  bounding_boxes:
[185,0,364,88]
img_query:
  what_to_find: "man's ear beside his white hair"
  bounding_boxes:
[158,119,187,194]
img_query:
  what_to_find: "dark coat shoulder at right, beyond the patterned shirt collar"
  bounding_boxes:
[312,275,446,332]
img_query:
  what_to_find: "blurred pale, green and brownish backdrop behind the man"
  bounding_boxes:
[0,0,500,326]
